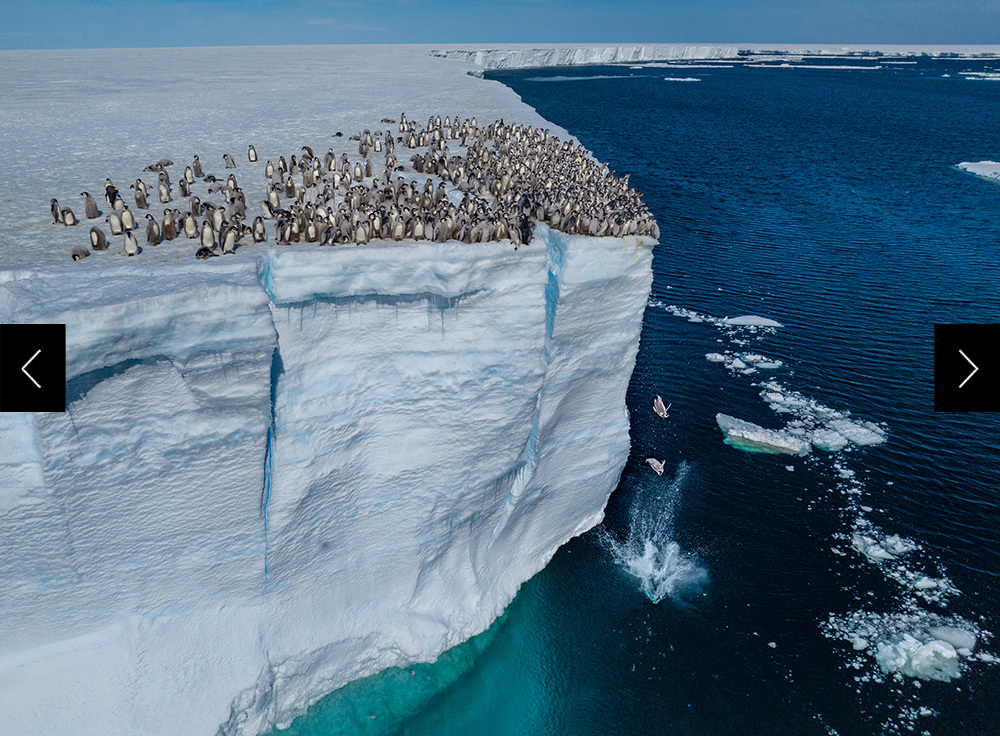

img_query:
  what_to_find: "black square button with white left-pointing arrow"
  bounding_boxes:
[0,325,66,411]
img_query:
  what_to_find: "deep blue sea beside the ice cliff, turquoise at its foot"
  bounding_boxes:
[278,59,1000,736]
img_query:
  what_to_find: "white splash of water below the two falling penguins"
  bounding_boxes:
[601,462,708,603]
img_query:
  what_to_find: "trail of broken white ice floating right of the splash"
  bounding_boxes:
[649,301,1000,734]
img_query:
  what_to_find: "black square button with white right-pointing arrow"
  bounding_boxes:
[934,324,1000,412]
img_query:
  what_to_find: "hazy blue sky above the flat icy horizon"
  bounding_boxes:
[0,0,1000,49]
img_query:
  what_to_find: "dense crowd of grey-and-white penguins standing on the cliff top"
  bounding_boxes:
[51,113,660,260]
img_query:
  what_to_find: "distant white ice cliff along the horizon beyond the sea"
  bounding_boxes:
[431,45,739,69]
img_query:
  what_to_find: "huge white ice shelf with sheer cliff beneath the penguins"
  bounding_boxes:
[0,46,651,736]
